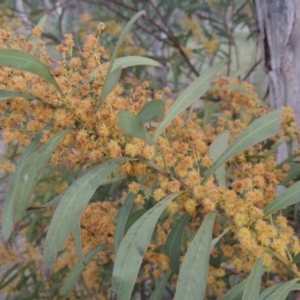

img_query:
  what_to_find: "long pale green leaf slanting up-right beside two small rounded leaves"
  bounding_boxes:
[154,61,225,141]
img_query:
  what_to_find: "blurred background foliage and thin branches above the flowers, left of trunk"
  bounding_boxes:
[1,0,266,98]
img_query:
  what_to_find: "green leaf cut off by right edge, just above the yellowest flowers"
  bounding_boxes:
[264,181,300,215]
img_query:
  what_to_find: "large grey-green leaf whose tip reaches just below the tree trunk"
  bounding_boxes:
[203,110,281,182]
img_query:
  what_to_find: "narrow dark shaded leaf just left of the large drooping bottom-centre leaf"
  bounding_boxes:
[114,193,135,254]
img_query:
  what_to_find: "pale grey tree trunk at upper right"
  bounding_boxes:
[254,0,300,169]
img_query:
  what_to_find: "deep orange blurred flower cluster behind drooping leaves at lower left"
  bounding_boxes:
[53,201,117,299]
